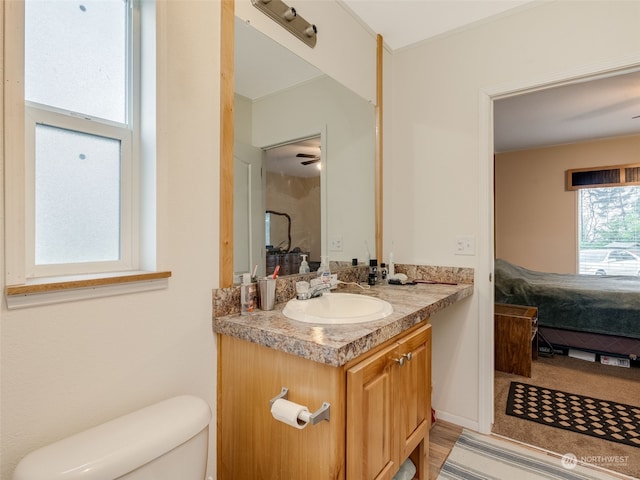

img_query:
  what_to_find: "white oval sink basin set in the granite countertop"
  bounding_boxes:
[282,293,393,325]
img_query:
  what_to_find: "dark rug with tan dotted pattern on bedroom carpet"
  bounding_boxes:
[506,382,640,447]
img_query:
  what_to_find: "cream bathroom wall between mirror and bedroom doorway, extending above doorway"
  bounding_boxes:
[384,0,640,431]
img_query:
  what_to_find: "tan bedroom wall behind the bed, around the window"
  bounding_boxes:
[495,135,640,273]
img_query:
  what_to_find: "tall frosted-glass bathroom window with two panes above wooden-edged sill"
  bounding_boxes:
[24,0,139,277]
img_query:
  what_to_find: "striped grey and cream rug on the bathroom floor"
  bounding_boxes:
[437,430,619,480]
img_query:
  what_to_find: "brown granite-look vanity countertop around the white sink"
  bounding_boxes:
[213,284,473,367]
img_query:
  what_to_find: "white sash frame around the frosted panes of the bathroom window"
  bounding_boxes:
[5,2,140,284]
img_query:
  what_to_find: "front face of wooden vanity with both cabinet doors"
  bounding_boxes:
[347,325,431,480]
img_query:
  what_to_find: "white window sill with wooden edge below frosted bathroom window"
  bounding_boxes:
[6,271,171,309]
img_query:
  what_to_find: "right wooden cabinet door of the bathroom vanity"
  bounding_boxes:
[396,325,431,459]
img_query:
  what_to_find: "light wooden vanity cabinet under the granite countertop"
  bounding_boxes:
[217,323,431,480]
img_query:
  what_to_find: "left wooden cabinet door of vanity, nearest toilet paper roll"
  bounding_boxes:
[347,345,399,480]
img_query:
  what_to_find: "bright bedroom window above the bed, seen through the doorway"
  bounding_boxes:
[578,186,640,276]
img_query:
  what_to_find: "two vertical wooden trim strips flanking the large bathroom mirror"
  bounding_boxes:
[218,0,384,288]
